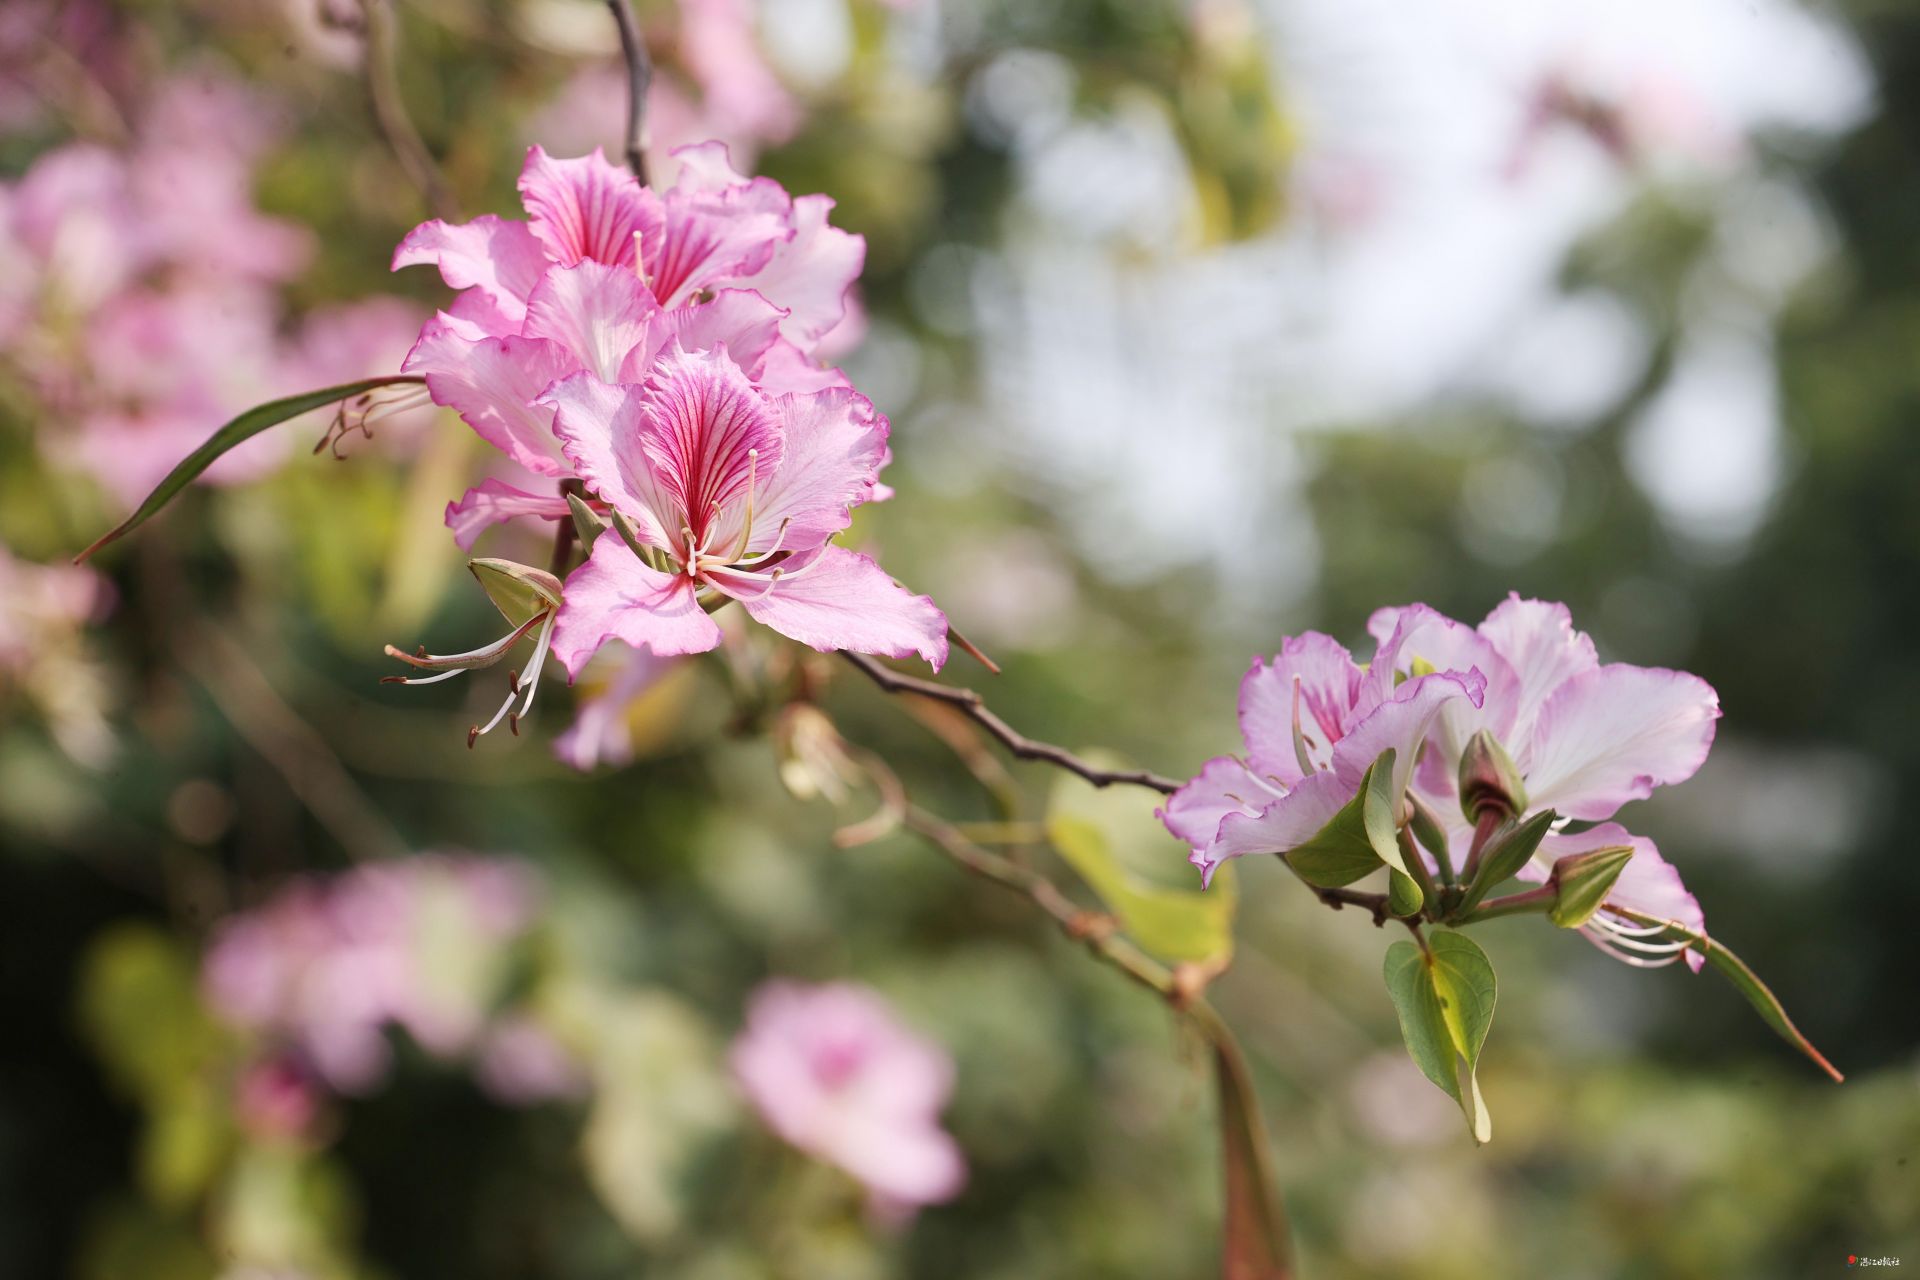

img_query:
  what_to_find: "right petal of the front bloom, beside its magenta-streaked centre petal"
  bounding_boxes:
[747,390,887,553]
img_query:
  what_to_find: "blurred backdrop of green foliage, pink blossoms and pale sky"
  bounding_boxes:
[0,0,1920,1280]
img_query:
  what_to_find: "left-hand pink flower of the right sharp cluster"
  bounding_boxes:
[1160,606,1486,883]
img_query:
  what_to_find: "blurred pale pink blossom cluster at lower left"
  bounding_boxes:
[202,854,536,1094]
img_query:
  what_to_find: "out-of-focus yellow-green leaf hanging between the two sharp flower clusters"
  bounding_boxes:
[1046,775,1236,963]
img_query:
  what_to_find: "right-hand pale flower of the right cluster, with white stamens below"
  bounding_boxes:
[1369,595,1720,971]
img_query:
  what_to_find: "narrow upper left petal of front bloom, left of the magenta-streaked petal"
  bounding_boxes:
[540,372,680,549]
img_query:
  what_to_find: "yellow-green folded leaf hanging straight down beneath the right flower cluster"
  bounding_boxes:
[1384,933,1496,1144]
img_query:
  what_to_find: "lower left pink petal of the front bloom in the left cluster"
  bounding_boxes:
[553,533,720,679]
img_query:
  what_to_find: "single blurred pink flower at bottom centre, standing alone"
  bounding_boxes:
[732,981,966,1213]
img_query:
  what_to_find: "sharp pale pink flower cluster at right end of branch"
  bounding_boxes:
[1162,595,1720,971]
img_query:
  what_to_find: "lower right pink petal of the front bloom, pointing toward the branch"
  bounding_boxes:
[708,545,947,670]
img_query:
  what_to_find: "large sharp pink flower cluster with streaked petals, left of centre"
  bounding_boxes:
[394,144,947,733]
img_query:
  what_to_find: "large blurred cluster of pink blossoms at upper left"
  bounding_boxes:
[0,75,419,503]
